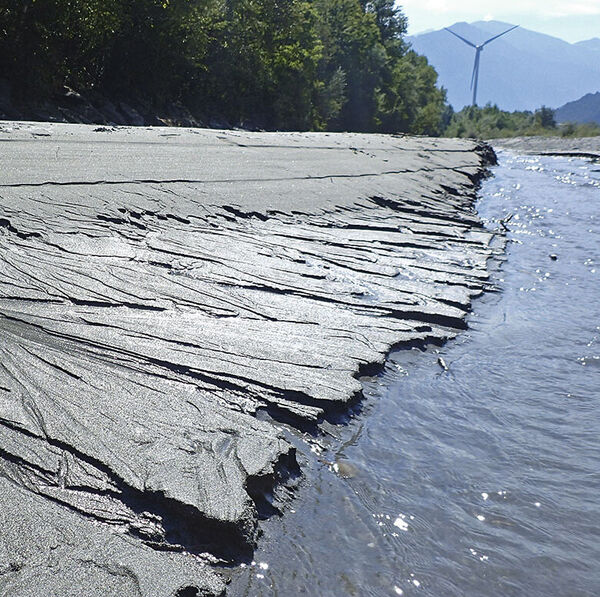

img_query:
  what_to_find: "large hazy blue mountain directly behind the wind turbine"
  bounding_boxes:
[408,21,600,110]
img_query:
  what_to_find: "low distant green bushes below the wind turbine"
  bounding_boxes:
[444,104,600,139]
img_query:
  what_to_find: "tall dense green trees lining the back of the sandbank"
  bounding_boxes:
[0,0,447,135]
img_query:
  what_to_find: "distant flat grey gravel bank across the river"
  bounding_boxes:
[489,137,600,160]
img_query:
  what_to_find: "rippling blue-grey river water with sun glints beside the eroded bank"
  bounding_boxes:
[228,153,600,597]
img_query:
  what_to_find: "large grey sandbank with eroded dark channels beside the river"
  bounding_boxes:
[0,122,498,597]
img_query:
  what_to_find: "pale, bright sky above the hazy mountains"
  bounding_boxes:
[398,0,600,43]
